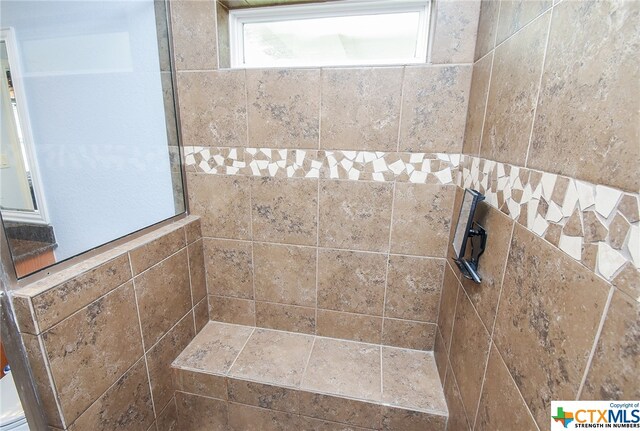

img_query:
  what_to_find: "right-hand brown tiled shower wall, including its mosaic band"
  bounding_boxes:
[435,0,640,430]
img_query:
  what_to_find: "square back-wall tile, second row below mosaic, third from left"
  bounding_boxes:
[318,249,387,316]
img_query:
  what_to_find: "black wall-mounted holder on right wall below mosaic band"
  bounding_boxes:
[453,189,487,283]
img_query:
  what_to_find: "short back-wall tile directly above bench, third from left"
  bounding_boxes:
[317,310,382,344]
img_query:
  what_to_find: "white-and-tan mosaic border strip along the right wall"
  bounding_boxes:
[457,155,640,281]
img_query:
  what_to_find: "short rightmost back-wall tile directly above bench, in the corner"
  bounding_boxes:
[382,318,438,350]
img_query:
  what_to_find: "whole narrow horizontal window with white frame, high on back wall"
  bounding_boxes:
[229,0,430,68]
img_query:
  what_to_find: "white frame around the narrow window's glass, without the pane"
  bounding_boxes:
[229,0,433,69]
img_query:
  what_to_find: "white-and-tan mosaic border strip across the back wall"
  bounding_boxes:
[185,146,460,184]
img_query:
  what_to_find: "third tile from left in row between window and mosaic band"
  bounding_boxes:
[320,67,403,151]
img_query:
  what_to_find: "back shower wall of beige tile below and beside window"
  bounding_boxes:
[172,1,480,349]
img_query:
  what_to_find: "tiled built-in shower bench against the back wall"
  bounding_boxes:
[172,322,448,431]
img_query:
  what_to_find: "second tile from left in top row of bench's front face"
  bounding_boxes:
[228,378,298,413]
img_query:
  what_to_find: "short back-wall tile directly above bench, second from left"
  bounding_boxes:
[256,301,316,334]
